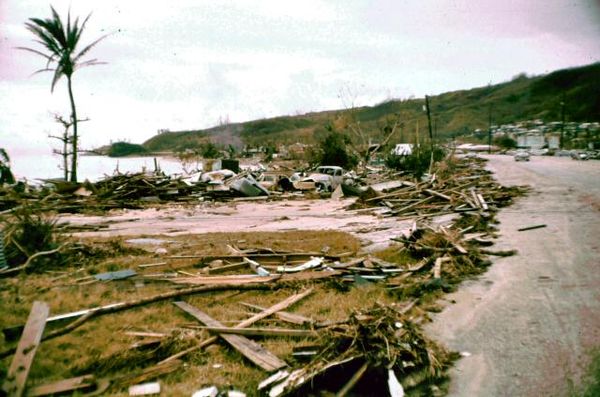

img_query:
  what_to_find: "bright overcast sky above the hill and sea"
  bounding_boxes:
[0,0,600,150]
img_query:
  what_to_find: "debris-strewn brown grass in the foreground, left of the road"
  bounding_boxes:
[0,154,522,395]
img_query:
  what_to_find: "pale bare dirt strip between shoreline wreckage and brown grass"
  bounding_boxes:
[60,199,412,251]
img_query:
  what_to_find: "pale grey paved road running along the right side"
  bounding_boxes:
[429,156,600,396]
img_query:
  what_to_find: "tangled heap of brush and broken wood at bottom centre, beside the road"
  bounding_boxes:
[259,305,456,397]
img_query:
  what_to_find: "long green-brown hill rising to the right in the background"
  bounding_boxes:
[143,63,600,151]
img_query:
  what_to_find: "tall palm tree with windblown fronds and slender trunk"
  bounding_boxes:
[19,6,107,182]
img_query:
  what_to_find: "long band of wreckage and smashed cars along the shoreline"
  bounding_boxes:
[0,160,351,215]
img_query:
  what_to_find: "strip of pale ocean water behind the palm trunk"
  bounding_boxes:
[9,152,183,183]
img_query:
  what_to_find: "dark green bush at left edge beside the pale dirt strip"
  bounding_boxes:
[3,207,61,268]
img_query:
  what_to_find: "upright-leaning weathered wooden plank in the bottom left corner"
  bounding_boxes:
[2,301,50,397]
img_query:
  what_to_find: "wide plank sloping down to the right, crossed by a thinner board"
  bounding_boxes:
[174,301,287,372]
